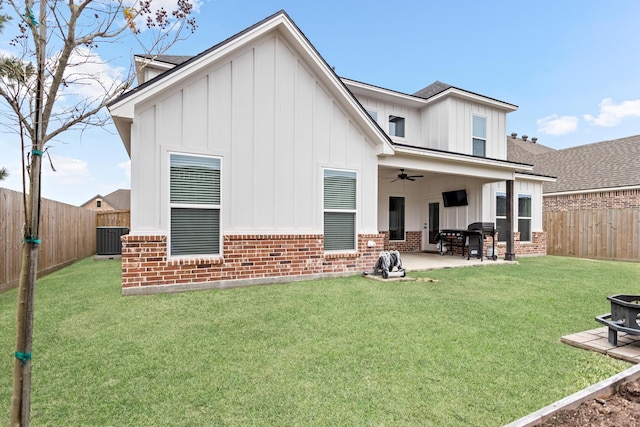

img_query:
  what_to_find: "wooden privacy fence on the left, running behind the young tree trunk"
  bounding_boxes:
[0,188,96,291]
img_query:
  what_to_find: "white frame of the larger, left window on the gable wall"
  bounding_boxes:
[166,151,223,259]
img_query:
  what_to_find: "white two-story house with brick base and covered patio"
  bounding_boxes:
[109,11,551,294]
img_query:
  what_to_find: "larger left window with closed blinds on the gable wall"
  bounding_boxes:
[169,154,220,256]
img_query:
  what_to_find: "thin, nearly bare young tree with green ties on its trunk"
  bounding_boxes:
[0,0,198,426]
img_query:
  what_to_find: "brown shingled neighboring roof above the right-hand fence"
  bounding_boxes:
[509,135,640,194]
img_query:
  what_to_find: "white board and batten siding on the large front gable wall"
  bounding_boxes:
[131,33,378,234]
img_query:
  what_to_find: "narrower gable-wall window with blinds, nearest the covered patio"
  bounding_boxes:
[324,169,356,251]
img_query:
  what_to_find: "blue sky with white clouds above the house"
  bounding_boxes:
[0,0,640,205]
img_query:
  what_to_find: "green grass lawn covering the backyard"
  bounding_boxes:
[0,257,640,426]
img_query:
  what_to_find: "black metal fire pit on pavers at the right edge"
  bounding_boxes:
[596,294,640,345]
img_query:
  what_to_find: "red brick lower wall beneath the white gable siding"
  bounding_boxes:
[122,234,384,295]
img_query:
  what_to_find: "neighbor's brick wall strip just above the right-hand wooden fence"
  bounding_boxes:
[543,188,640,212]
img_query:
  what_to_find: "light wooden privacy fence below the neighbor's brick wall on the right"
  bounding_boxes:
[543,208,640,261]
